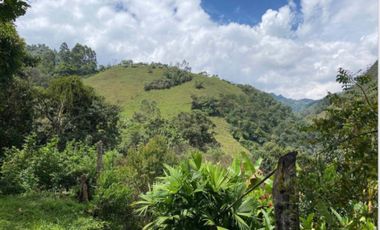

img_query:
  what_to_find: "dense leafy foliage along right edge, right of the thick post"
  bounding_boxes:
[301,66,378,226]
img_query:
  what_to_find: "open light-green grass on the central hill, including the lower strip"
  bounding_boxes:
[84,66,247,154]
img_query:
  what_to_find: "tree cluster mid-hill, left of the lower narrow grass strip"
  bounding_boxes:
[121,100,217,154]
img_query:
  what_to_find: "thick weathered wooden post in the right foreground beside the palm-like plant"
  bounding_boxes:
[272,152,300,230]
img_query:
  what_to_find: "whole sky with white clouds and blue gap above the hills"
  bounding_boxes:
[16,0,378,99]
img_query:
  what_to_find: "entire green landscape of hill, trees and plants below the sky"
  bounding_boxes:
[0,1,378,230]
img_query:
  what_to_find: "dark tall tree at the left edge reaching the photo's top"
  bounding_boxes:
[0,0,31,158]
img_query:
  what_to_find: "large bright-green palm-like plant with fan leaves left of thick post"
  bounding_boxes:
[135,153,273,229]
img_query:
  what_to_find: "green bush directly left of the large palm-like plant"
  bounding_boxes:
[93,136,175,229]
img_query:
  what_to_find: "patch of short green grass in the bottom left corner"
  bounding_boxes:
[0,193,104,230]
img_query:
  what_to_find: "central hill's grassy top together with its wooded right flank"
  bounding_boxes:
[84,63,300,156]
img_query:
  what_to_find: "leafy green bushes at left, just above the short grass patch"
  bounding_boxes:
[0,135,96,194]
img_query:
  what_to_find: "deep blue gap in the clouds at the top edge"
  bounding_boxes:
[201,0,299,26]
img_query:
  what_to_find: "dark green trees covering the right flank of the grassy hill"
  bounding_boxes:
[191,85,304,171]
